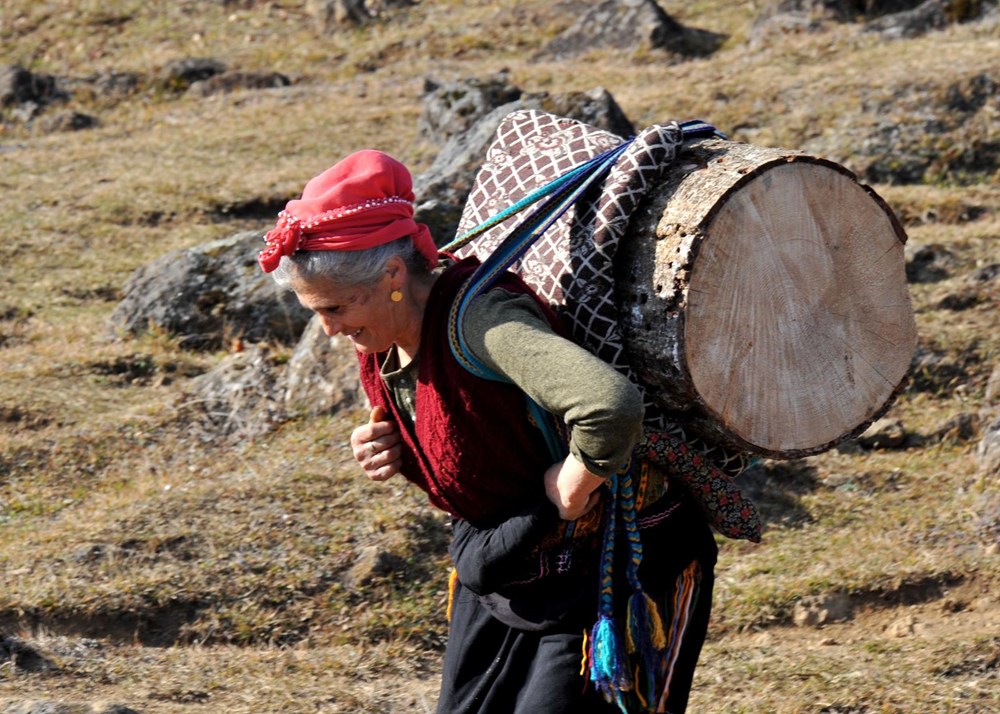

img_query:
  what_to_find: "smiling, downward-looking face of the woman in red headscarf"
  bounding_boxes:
[293,274,402,354]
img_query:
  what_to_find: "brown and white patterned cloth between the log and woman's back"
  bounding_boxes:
[456,110,760,540]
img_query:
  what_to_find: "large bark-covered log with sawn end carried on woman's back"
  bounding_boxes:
[615,139,916,458]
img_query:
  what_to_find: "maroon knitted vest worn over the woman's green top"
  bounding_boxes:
[358,258,563,527]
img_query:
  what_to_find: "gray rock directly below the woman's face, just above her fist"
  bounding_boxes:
[284,317,366,416]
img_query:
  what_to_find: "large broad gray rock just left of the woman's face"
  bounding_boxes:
[110,231,311,349]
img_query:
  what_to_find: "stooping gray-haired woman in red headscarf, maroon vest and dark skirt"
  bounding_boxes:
[259,150,716,714]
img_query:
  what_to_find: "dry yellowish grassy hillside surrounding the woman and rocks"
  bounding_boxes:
[0,0,1000,714]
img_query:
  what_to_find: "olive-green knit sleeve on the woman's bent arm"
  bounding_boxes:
[462,289,643,476]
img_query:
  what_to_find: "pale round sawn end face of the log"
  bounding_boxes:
[684,162,916,452]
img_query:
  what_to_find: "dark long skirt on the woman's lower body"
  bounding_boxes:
[437,502,718,714]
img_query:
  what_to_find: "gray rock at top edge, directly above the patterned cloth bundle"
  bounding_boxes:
[537,0,726,59]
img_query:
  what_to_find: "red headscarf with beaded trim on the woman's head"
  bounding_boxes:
[257,149,437,273]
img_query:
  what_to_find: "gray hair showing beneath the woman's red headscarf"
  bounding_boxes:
[271,236,430,290]
